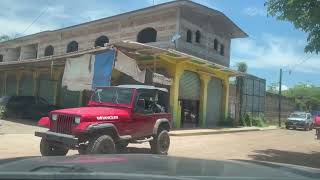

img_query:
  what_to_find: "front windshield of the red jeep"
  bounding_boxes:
[91,87,133,105]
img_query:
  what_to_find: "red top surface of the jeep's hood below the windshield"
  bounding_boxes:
[51,107,130,117]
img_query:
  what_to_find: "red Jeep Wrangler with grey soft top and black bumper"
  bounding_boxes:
[35,85,172,156]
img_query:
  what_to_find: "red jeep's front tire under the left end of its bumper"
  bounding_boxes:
[40,138,69,156]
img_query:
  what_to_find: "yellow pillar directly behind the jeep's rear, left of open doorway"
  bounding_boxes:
[170,66,183,128]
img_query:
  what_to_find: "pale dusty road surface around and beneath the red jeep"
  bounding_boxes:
[0,119,320,168]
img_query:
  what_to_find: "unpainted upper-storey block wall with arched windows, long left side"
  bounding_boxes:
[0,8,177,61]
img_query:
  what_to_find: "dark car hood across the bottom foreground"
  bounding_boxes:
[0,154,320,179]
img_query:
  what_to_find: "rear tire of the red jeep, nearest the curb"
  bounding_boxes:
[150,130,170,155]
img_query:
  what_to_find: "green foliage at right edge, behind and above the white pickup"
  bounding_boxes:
[283,84,320,111]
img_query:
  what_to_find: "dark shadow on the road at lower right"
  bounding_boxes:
[249,149,320,168]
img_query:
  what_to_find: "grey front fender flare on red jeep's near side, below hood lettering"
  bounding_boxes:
[87,123,120,140]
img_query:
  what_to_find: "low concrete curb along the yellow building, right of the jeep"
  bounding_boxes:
[169,128,279,136]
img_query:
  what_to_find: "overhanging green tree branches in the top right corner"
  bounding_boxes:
[265,0,320,54]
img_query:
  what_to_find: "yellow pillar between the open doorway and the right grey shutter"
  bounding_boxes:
[199,74,211,127]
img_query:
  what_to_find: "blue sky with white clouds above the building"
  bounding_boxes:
[0,0,320,87]
